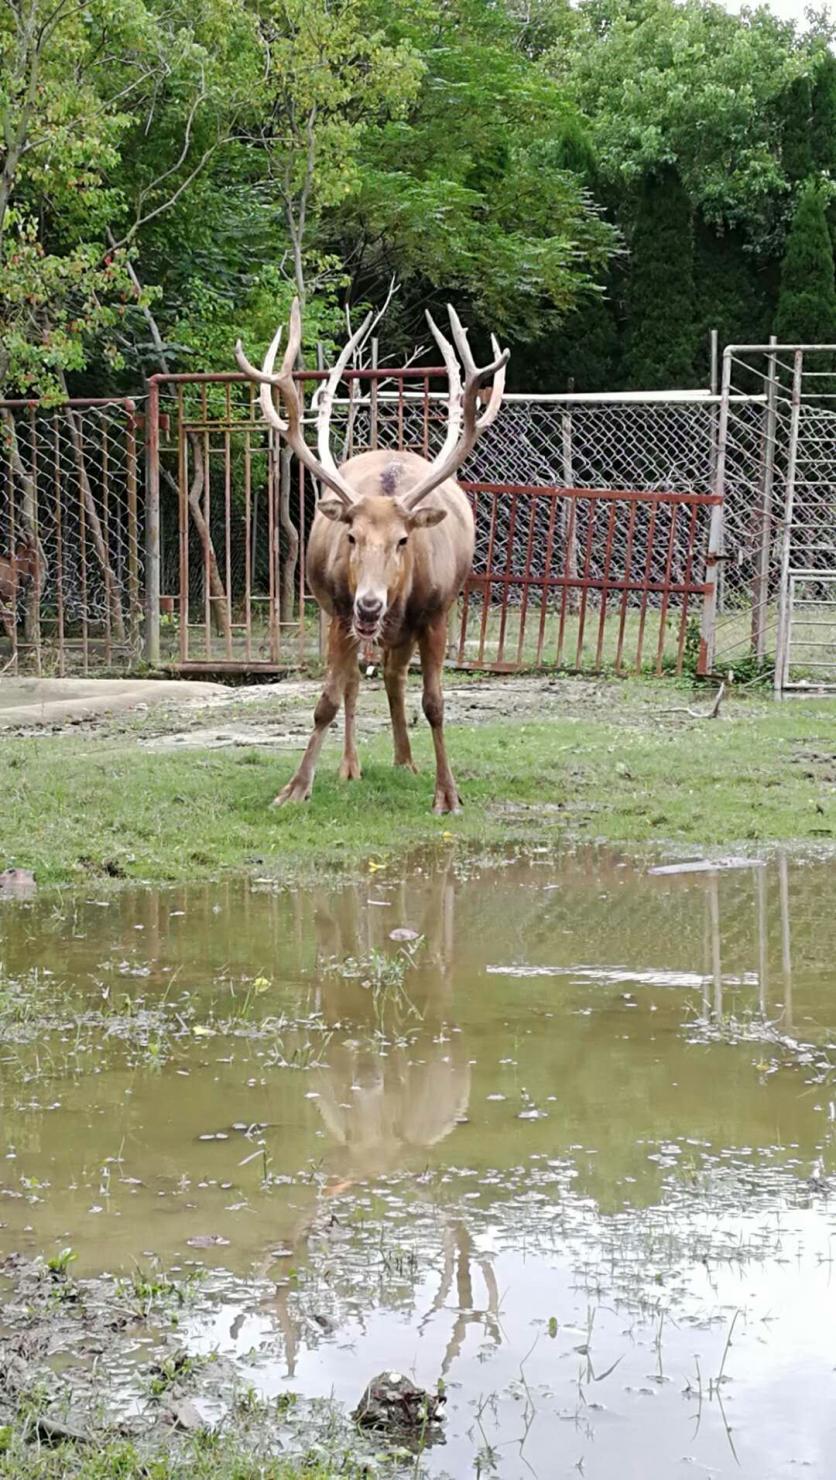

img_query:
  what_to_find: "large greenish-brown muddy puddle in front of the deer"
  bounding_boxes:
[0,851,836,1480]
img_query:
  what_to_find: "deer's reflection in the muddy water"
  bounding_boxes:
[257,864,500,1376]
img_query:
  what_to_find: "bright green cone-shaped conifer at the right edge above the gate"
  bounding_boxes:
[775,181,836,345]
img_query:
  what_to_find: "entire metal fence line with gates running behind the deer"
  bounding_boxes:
[0,358,836,679]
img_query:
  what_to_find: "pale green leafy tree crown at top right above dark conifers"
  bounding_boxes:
[546,0,821,244]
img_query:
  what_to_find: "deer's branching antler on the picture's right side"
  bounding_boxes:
[401,303,510,512]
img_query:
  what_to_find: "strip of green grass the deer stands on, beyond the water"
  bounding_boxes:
[0,679,836,884]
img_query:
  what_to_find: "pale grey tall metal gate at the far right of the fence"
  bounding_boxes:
[704,340,836,693]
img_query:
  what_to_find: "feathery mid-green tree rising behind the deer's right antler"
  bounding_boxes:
[330,0,616,343]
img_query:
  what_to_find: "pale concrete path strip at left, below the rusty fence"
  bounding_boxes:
[0,678,229,730]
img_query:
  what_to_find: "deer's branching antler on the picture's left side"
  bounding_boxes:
[235,297,365,508]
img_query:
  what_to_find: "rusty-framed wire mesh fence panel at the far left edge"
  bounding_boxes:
[0,400,144,675]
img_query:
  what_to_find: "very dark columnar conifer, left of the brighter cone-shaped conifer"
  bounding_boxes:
[623,166,695,391]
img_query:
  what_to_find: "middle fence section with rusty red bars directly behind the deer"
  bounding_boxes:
[146,369,722,673]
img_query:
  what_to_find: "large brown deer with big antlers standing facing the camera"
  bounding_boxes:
[235,299,510,814]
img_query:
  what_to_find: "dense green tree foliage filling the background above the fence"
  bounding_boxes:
[0,0,836,397]
